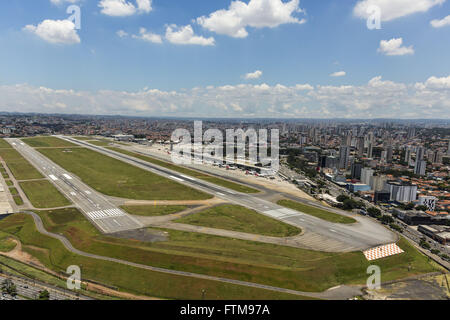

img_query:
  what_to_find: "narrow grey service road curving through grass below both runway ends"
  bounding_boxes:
[19,211,362,300]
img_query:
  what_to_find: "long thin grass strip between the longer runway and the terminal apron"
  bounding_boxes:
[108,147,259,193]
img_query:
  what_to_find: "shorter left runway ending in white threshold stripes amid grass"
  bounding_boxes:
[6,139,143,233]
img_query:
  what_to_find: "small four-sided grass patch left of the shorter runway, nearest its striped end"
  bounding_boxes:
[19,180,71,208]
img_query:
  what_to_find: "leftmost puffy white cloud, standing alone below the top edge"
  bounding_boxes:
[23,20,81,44]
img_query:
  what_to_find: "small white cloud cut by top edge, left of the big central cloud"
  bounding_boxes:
[98,0,152,17]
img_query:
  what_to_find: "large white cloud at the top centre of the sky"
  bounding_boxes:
[197,0,306,38]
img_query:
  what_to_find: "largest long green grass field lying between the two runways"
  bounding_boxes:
[39,148,212,200]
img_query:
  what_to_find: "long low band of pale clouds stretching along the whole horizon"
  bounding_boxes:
[0,76,450,119]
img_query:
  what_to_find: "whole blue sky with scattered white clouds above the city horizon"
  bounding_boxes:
[0,0,450,118]
